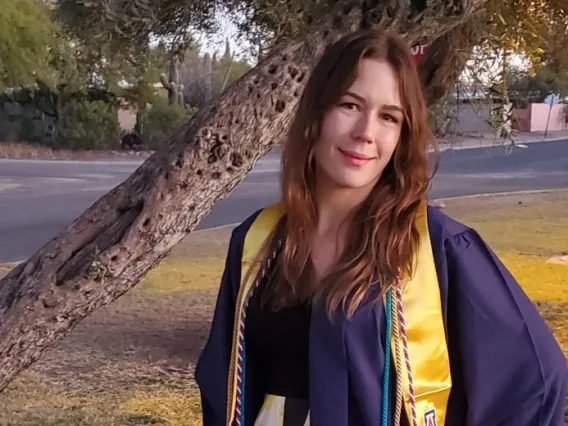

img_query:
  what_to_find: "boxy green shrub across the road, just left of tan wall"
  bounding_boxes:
[56,101,120,149]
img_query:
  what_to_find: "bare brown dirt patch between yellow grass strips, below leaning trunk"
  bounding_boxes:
[25,287,217,392]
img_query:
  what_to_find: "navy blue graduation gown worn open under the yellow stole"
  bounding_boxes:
[195,207,568,426]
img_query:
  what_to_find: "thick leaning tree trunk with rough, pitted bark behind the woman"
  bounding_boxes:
[0,0,484,390]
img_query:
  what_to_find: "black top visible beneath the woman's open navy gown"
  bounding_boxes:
[245,284,311,398]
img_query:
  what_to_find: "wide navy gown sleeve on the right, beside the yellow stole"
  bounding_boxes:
[446,229,567,426]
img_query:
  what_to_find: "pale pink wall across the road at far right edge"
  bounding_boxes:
[513,104,568,132]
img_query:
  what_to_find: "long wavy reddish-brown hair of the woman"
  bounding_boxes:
[264,30,434,316]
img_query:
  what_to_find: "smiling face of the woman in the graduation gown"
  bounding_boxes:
[315,59,404,193]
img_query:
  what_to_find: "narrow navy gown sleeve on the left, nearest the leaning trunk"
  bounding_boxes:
[195,229,243,426]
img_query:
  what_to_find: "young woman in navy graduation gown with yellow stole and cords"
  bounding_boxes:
[196,31,567,426]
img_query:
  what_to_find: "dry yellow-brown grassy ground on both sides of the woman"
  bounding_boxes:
[0,191,568,426]
